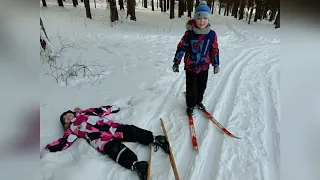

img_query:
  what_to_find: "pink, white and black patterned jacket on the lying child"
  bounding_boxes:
[45,106,123,152]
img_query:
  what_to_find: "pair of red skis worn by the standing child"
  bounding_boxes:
[183,92,241,150]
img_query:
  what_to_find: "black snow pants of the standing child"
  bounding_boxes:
[186,70,208,107]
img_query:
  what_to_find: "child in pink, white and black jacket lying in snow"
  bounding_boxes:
[41,106,170,180]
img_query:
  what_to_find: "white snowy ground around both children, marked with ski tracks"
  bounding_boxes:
[40,2,280,180]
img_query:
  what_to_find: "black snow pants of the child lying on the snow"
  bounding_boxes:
[104,125,153,169]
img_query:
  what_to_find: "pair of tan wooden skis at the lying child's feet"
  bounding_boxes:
[147,118,180,180]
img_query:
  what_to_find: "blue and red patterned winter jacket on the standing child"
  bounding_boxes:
[173,20,219,73]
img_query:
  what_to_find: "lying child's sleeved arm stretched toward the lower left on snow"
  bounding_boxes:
[45,128,78,152]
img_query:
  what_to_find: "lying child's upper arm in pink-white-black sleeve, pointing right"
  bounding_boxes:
[76,105,120,117]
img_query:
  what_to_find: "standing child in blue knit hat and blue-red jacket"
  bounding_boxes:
[172,1,220,116]
